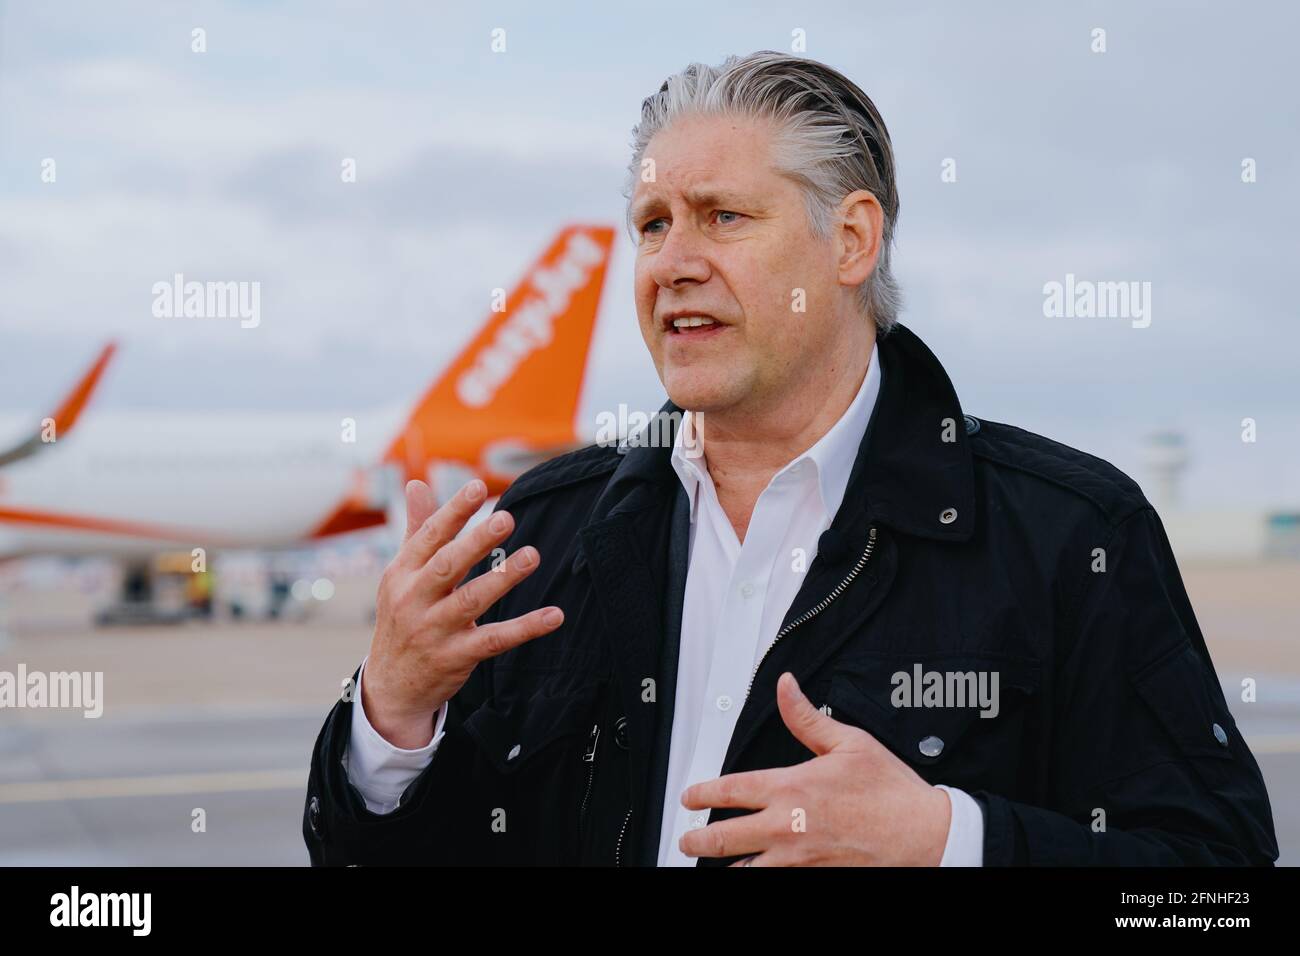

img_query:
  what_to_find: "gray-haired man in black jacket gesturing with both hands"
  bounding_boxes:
[303,53,1277,866]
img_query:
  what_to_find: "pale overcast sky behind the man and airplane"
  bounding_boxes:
[0,0,1300,507]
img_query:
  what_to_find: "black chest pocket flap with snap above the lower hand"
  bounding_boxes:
[828,653,1039,765]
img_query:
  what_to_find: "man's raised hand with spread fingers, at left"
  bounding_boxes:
[361,479,564,750]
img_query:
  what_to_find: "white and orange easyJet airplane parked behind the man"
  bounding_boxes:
[0,225,615,613]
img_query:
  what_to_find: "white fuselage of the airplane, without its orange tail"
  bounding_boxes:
[0,408,403,557]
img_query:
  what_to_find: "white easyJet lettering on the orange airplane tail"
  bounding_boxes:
[456,232,605,408]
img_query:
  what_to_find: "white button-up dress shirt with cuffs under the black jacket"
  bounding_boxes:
[343,349,984,866]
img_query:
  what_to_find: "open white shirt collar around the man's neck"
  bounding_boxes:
[671,345,881,522]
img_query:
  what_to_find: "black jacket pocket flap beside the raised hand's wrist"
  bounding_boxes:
[465,685,598,774]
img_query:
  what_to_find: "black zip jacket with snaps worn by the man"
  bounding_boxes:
[303,326,1278,866]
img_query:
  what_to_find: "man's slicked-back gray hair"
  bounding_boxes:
[624,51,902,333]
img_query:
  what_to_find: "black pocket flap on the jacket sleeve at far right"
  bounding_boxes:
[1131,643,1236,760]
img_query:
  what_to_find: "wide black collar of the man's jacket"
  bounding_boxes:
[590,324,976,541]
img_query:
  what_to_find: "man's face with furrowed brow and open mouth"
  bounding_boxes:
[632,116,847,414]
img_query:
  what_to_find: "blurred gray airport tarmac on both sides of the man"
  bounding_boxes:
[0,564,1300,866]
